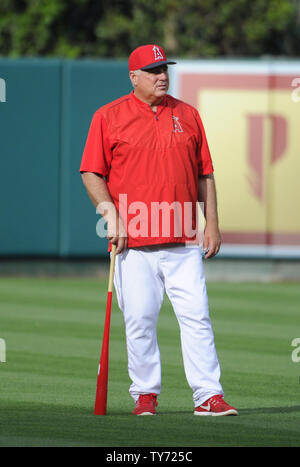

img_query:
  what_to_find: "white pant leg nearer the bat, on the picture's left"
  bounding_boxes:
[114,249,164,400]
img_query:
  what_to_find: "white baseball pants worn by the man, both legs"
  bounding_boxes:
[114,245,224,406]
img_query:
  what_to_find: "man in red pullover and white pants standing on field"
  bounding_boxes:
[80,44,238,416]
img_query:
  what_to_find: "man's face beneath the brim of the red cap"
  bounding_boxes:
[130,65,169,103]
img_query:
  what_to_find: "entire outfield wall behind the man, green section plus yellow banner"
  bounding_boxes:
[0,59,300,259]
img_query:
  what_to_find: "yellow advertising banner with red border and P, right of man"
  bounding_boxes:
[171,60,300,258]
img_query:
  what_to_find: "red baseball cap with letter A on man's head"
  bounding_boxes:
[128,44,176,71]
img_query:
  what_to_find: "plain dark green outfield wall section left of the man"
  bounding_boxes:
[0,59,130,257]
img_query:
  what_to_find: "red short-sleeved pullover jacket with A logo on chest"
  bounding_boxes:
[80,92,213,248]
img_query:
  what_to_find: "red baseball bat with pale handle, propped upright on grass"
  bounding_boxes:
[94,245,116,415]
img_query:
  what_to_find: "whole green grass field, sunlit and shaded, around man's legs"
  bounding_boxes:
[0,278,300,447]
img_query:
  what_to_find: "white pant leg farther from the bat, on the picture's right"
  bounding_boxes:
[161,246,224,406]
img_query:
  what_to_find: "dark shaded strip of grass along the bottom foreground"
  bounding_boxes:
[4,404,297,447]
